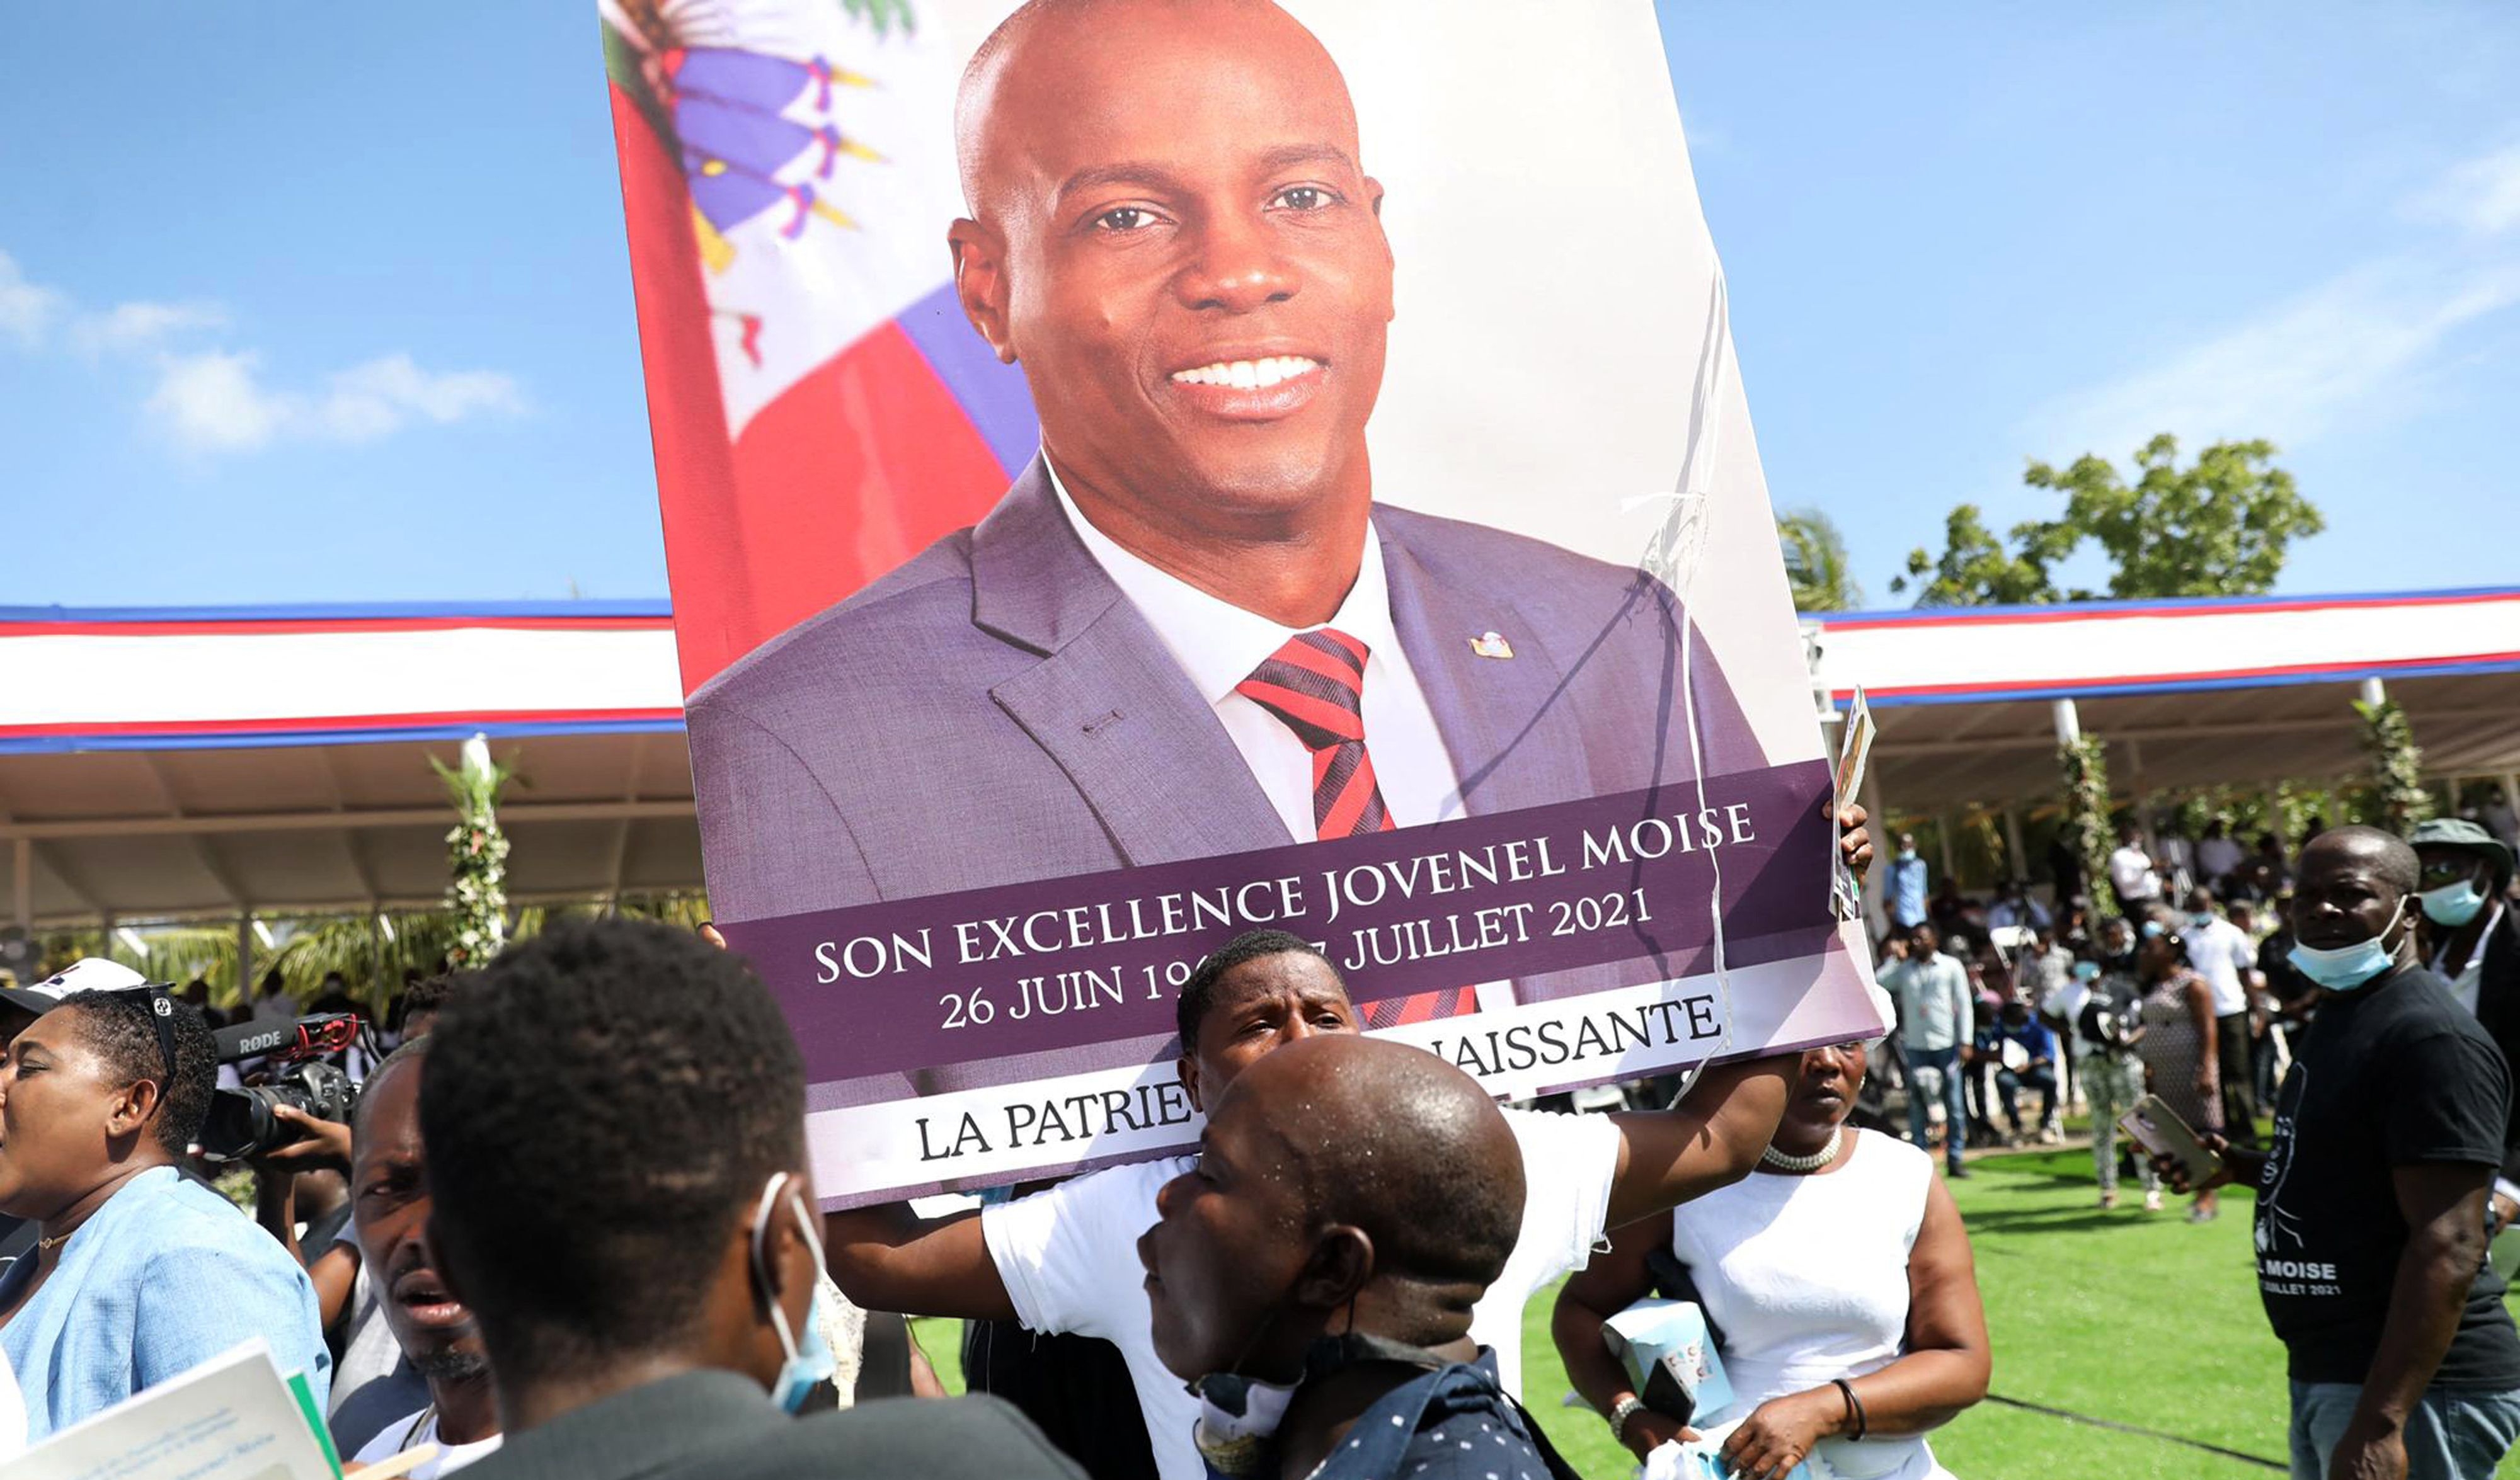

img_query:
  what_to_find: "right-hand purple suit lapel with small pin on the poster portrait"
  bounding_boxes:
[1376,521,1595,816]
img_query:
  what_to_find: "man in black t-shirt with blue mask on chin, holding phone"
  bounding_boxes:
[2155,828,2520,1480]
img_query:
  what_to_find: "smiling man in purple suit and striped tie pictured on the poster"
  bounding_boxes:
[688,0,1767,1027]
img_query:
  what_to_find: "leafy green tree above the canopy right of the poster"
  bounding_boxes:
[1890,433,2326,606]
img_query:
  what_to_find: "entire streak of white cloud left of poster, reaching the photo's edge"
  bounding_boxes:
[0,252,527,453]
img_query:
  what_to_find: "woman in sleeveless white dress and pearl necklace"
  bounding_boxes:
[1552,1042,1988,1480]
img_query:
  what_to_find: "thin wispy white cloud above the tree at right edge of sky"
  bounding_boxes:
[2024,146,2520,458]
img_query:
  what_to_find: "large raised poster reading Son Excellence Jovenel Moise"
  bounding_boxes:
[605,0,1882,1203]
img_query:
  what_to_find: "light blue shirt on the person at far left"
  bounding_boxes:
[0,1165,333,1440]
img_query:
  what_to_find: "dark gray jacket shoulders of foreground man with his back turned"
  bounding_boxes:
[464,1372,1084,1480]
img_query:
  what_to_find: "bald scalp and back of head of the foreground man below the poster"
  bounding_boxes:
[1220,1037,1522,1289]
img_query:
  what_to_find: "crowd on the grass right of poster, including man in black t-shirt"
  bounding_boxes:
[1875,811,2520,1477]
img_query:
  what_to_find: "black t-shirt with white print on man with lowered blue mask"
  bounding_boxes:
[2255,967,2520,1389]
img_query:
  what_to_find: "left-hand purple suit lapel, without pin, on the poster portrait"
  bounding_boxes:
[970,458,1293,863]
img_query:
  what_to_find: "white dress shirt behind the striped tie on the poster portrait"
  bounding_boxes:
[1041,455,1469,843]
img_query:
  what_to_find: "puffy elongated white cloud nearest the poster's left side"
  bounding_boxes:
[144,350,524,453]
